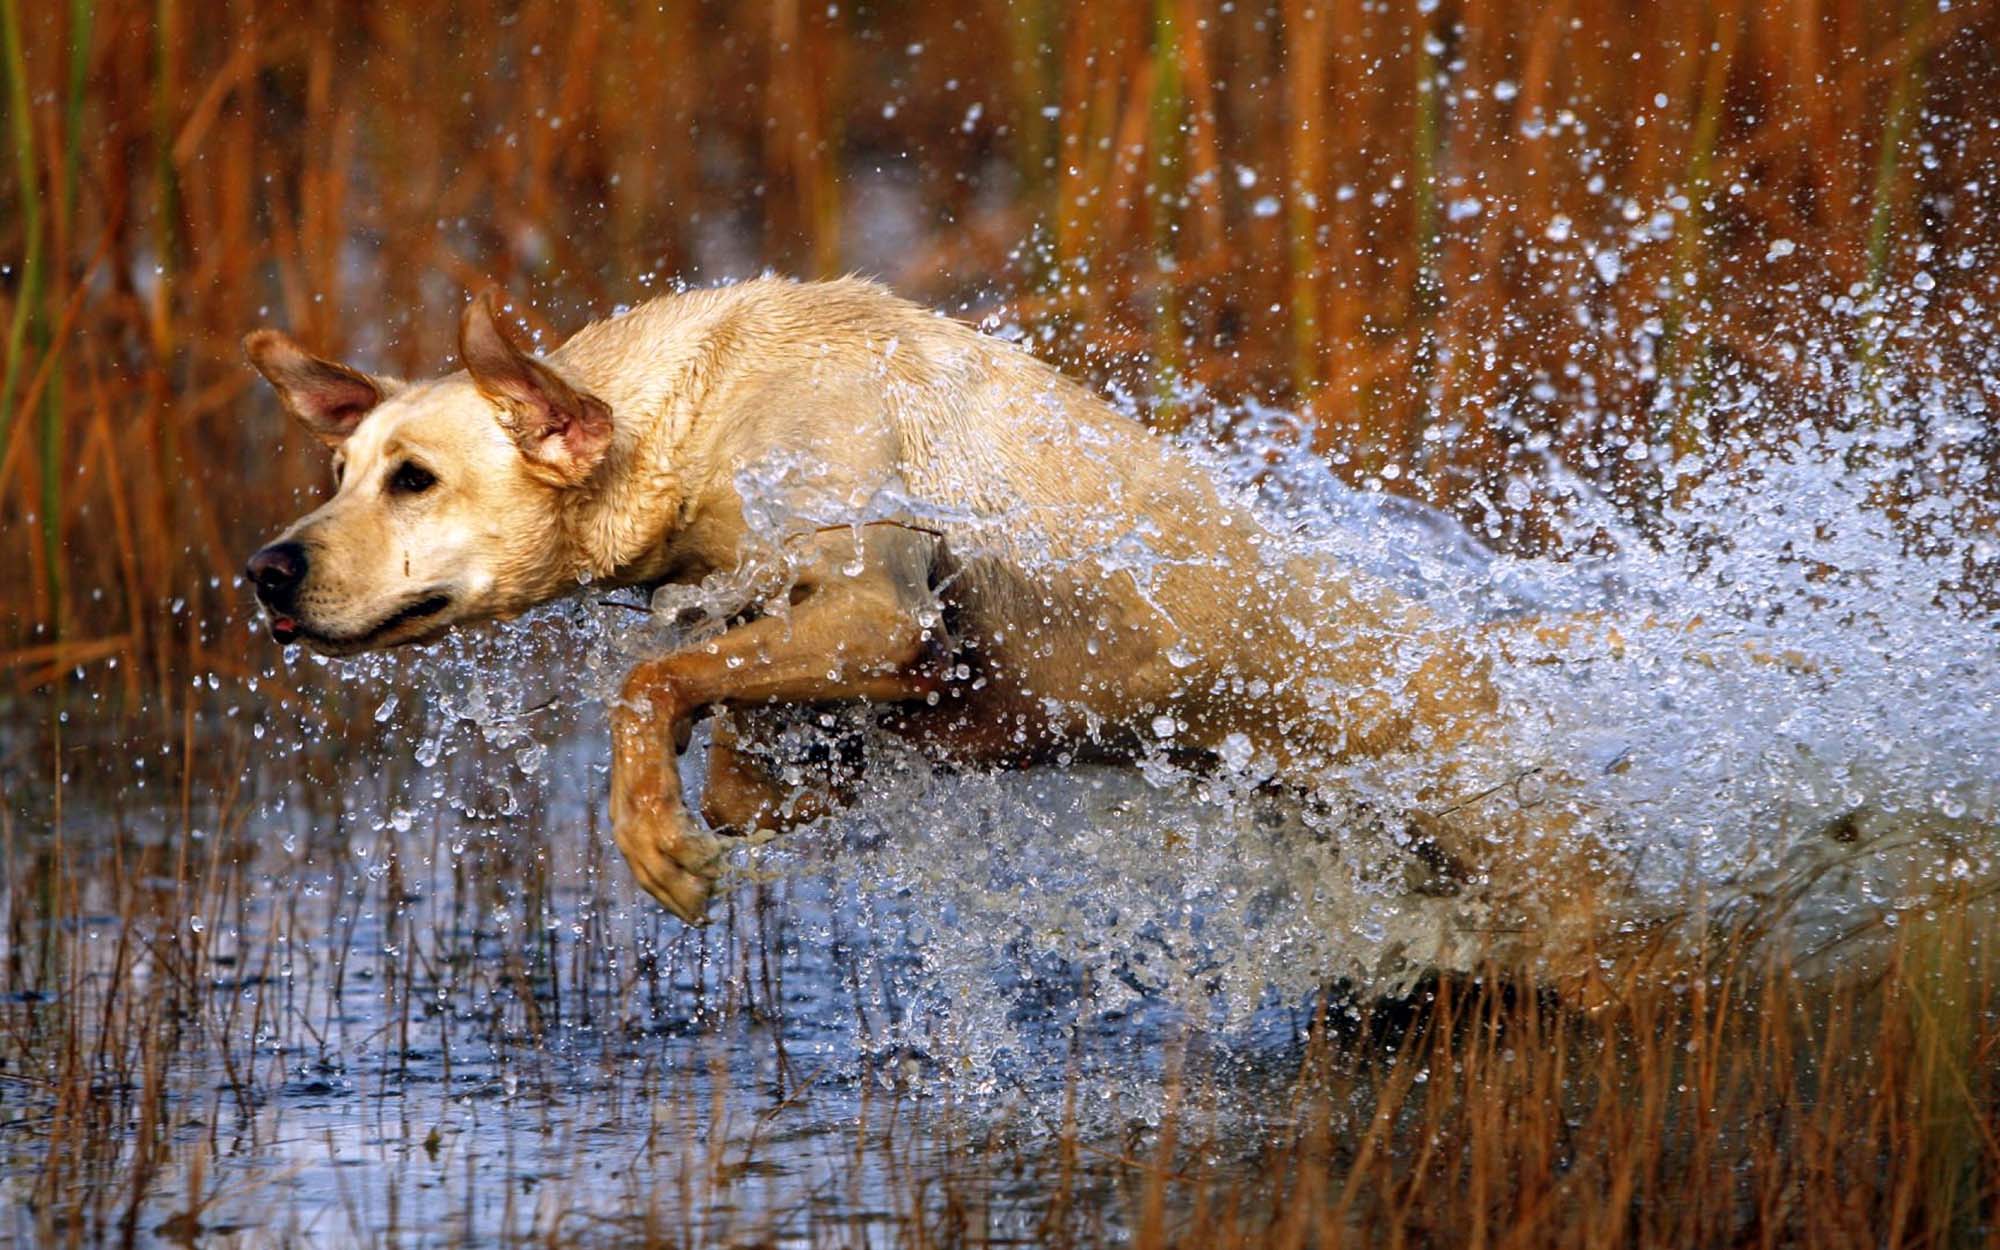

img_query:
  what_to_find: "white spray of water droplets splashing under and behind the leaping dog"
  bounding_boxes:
[290,282,2000,1120]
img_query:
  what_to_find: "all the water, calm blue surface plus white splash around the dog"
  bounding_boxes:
[0,298,2000,1242]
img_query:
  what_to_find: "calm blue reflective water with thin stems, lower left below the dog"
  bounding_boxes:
[0,716,1152,1244]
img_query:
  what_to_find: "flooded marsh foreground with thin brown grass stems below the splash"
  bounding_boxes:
[0,716,2000,1246]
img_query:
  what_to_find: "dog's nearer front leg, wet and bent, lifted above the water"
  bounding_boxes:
[612,530,936,924]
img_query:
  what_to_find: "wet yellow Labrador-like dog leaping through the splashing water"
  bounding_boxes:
[244,278,1576,940]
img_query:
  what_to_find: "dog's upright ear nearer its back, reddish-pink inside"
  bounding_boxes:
[458,290,612,486]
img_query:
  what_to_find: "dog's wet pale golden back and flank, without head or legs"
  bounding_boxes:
[558,280,1490,768]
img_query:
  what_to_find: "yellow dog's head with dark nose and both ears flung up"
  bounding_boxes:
[244,296,612,654]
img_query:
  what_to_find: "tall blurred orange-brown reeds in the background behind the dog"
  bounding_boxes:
[0,0,2000,686]
